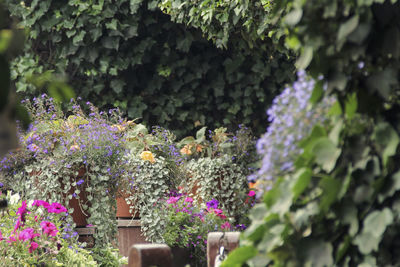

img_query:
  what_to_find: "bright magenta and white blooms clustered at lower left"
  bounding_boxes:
[0,193,88,266]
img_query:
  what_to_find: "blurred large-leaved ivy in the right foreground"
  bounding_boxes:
[209,0,400,267]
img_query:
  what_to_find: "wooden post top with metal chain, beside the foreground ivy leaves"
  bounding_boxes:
[207,232,240,267]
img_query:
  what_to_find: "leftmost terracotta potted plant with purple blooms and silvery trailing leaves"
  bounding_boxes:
[0,95,139,243]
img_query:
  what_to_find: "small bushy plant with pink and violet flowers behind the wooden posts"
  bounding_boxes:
[160,194,233,266]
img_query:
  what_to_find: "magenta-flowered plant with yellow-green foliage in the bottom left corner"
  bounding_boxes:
[0,194,97,266]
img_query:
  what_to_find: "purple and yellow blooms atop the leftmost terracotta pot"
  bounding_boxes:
[0,94,127,185]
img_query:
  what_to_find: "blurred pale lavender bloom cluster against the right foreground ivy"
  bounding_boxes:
[249,71,335,193]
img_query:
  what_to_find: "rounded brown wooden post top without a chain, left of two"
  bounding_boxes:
[128,244,172,267]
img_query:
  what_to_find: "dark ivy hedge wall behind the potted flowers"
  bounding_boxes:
[6,0,294,137]
